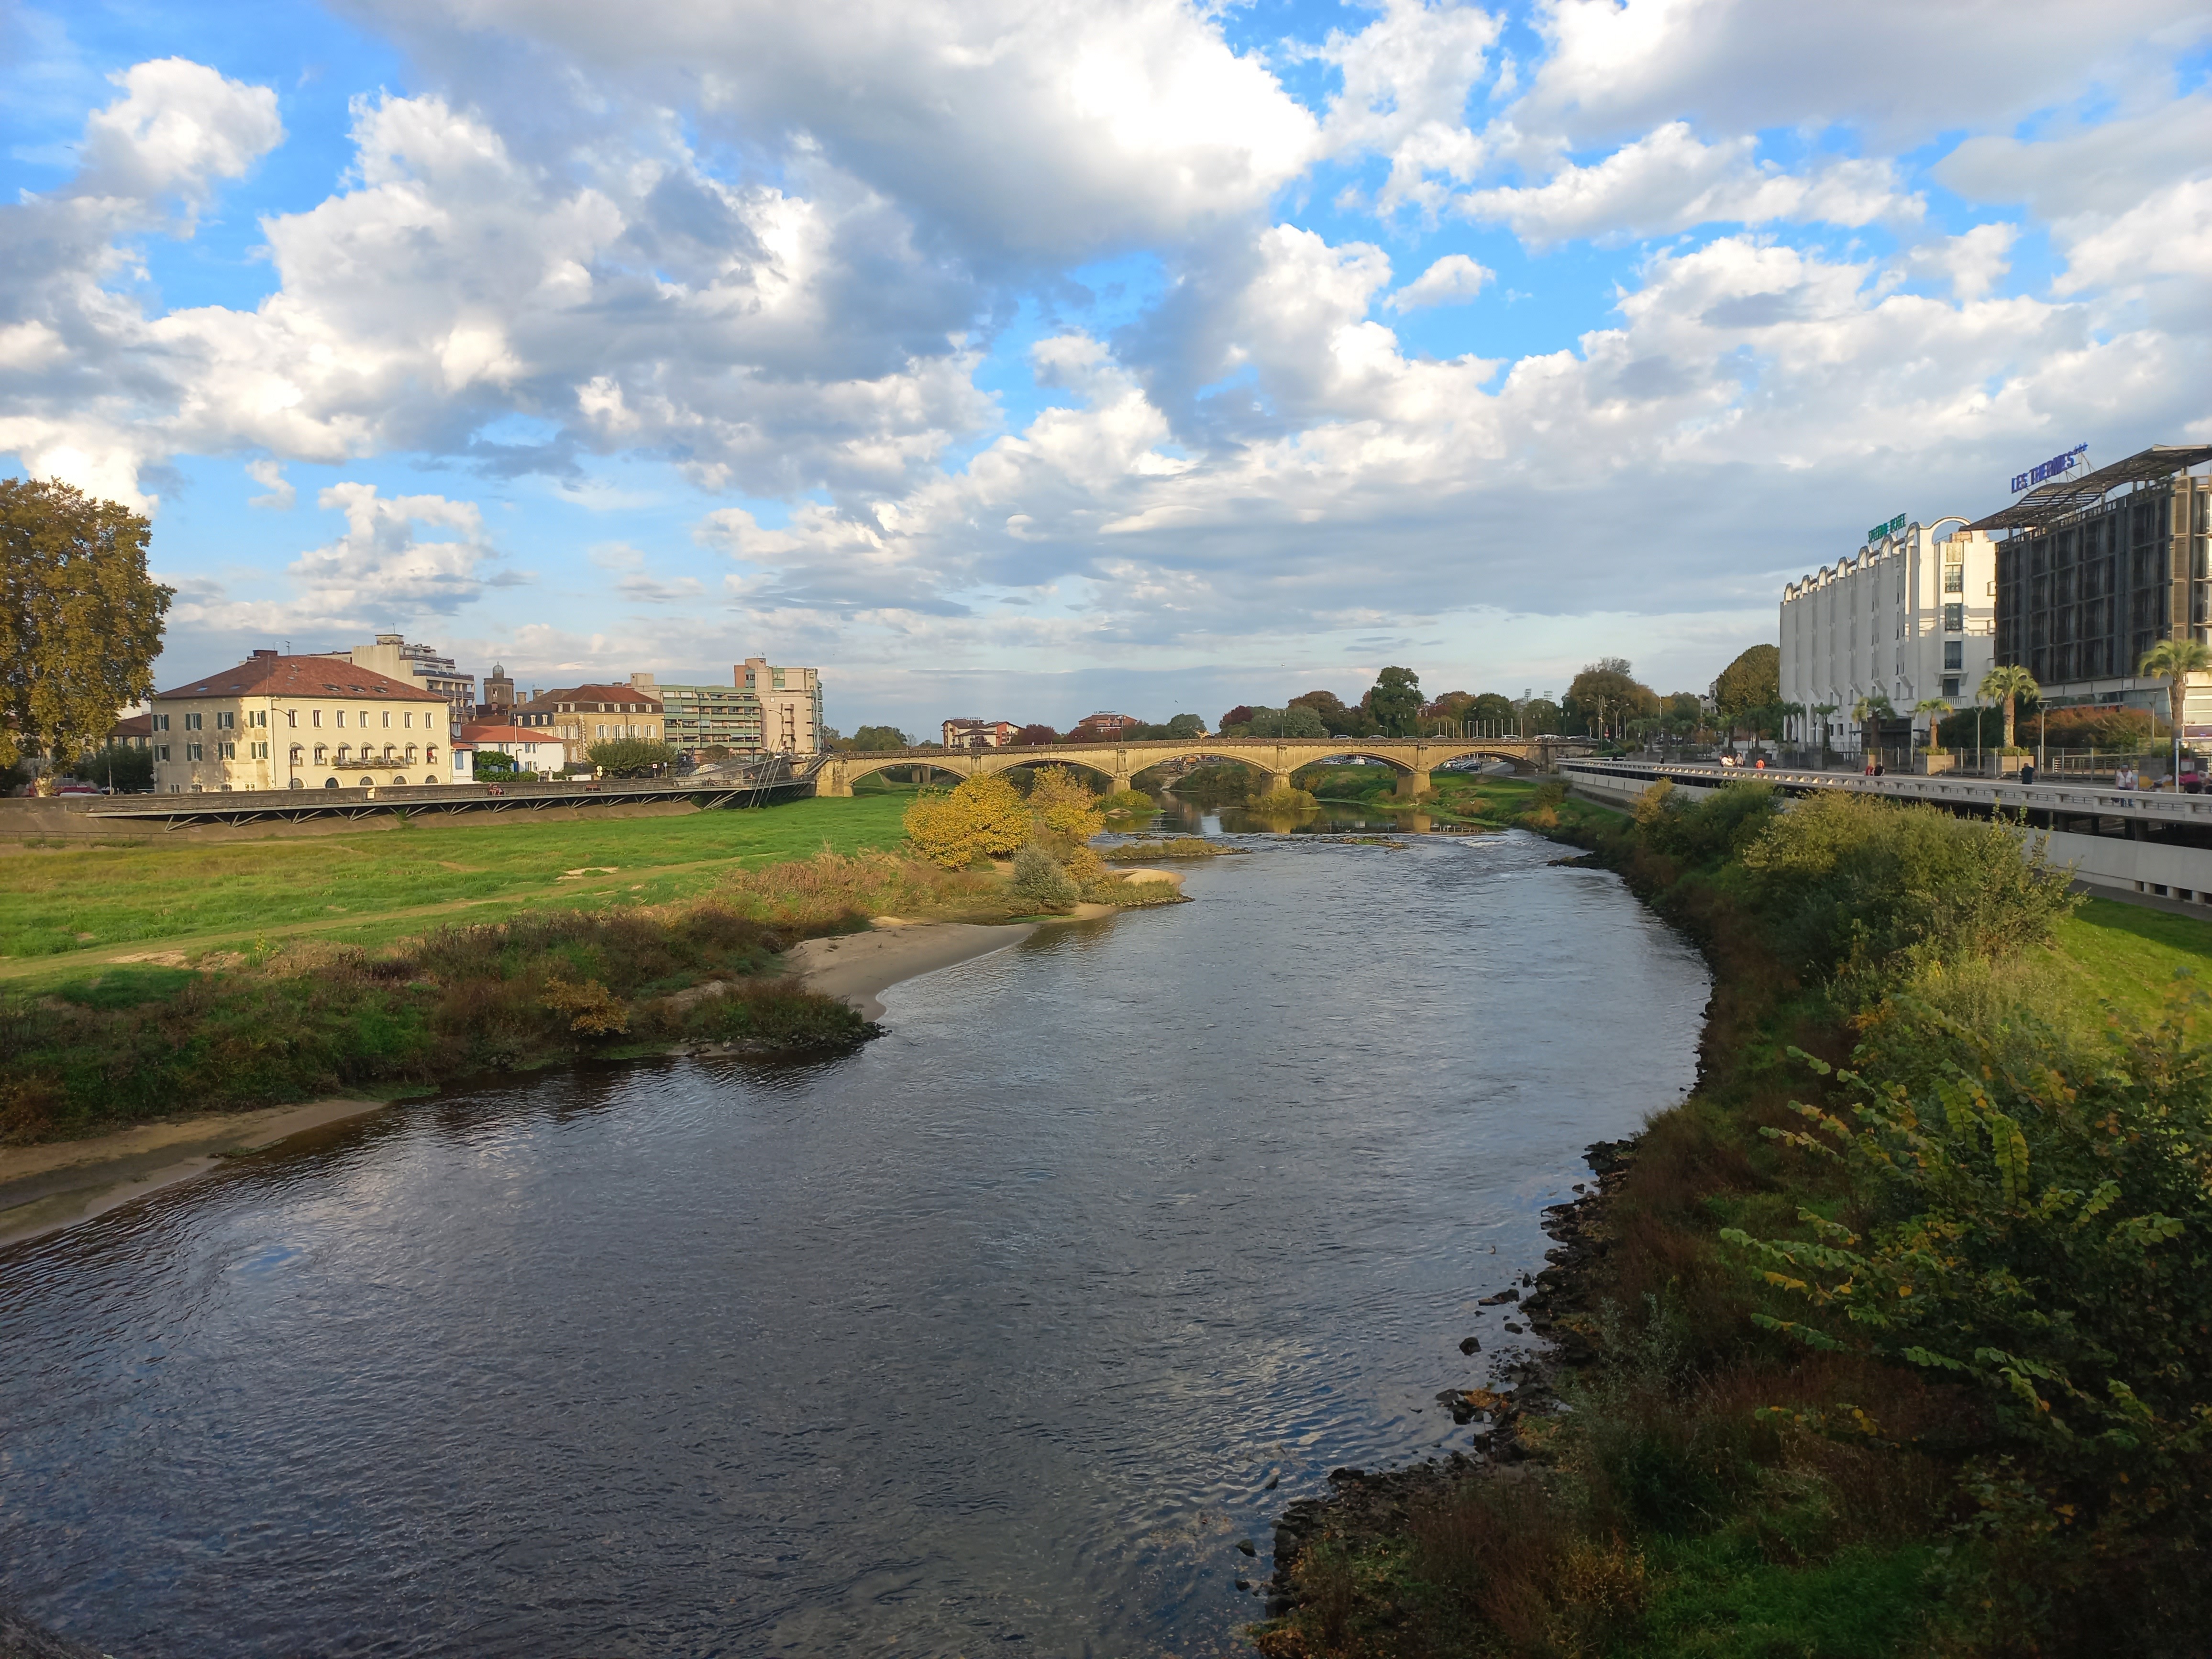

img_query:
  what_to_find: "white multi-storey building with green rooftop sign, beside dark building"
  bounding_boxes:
[1781,513,1997,748]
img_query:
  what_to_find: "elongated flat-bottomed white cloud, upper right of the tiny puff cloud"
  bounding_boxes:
[1451,122,1922,248]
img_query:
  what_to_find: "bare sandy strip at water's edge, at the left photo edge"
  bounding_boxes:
[0,1099,385,1245]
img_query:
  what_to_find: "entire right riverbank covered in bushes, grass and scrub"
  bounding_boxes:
[1259,785,2212,1659]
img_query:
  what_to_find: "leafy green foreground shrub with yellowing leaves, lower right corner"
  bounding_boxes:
[1723,989,2212,1630]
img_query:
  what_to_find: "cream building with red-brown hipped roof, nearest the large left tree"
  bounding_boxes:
[148,650,453,794]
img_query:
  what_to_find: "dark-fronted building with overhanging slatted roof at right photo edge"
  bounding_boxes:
[1975,444,2212,737]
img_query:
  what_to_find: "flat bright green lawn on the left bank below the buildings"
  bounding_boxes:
[0,794,907,980]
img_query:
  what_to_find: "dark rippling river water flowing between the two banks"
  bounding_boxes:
[0,832,1708,1659]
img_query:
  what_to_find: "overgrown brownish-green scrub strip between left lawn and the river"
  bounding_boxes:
[0,854,1031,1144]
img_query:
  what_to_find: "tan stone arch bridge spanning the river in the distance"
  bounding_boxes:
[814,737,1591,798]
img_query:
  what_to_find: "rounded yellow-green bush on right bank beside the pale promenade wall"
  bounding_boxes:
[1714,785,2075,986]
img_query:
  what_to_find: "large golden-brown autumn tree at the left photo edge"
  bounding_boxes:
[0,478,175,765]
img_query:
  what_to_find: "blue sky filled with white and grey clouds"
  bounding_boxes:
[0,0,2212,734]
